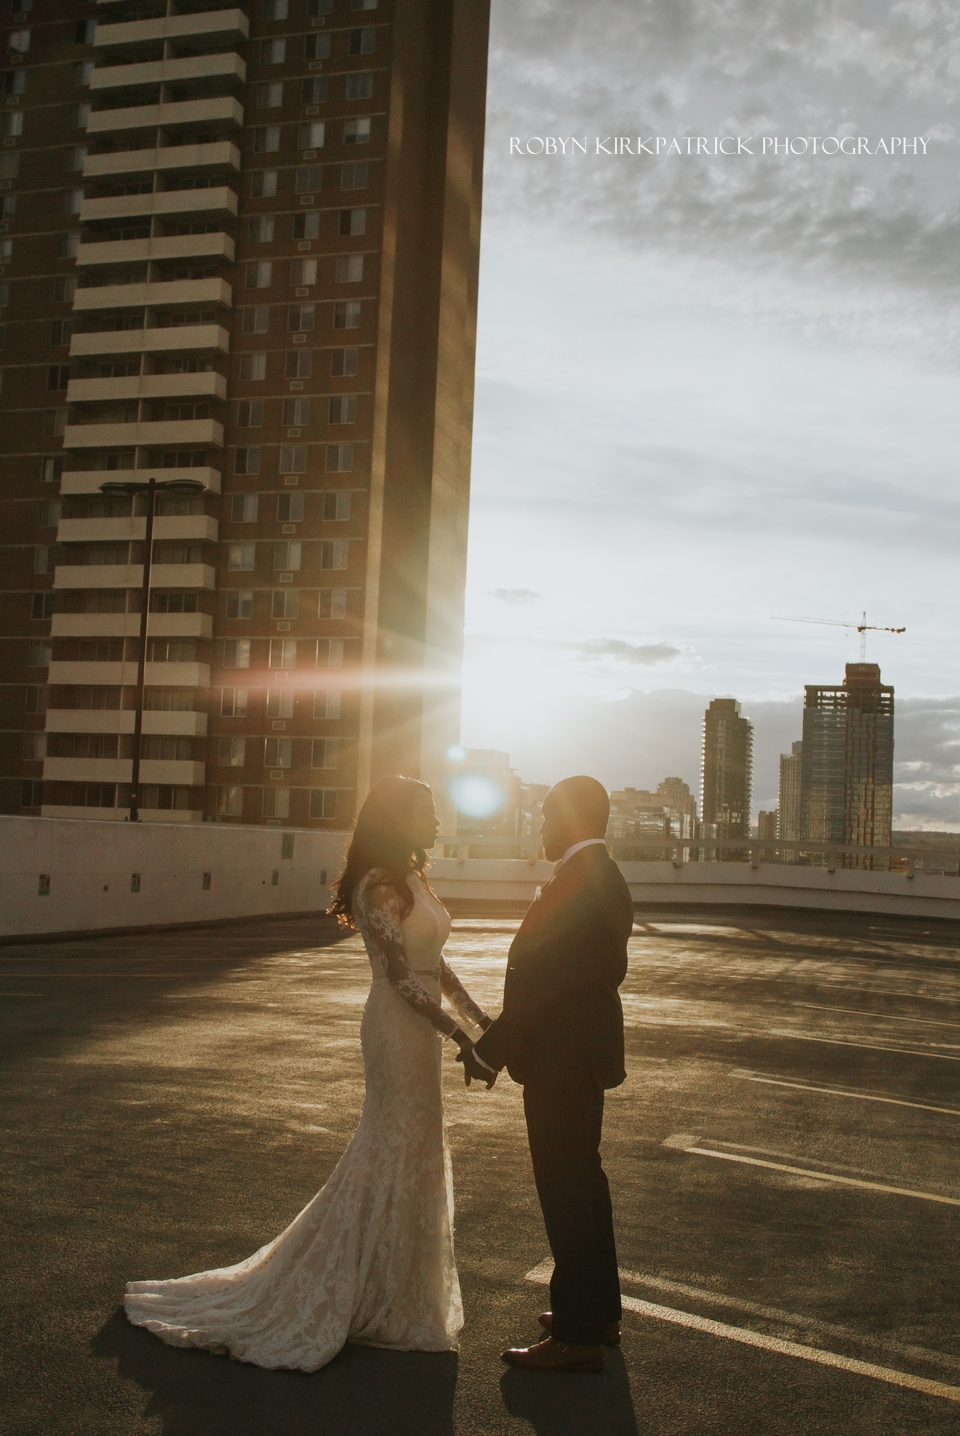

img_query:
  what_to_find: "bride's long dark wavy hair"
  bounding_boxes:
[327,773,430,928]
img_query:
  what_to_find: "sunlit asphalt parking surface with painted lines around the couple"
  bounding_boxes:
[0,910,960,1436]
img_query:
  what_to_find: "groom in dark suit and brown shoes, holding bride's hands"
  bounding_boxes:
[465,777,633,1371]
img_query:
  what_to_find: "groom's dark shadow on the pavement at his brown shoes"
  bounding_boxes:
[499,1351,637,1436]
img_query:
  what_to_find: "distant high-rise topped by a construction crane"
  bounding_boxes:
[801,663,894,867]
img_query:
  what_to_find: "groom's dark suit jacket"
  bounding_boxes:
[476,844,633,1087]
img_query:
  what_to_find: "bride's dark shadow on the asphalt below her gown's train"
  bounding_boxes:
[92,1310,456,1436]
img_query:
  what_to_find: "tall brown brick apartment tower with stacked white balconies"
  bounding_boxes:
[0,0,488,827]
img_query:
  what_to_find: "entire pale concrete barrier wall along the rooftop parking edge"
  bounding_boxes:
[0,816,960,941]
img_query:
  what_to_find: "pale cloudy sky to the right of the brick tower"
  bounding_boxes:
[462,0,960,831]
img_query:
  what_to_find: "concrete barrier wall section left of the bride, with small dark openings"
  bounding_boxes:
[0,816,347,939]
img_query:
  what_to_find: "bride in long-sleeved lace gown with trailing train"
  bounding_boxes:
[123,777,492,1371]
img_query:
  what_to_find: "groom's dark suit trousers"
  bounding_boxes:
[524,1084,623,1346]
